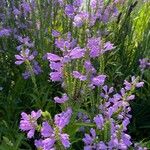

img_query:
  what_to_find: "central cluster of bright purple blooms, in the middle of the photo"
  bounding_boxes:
[47,31,115,86]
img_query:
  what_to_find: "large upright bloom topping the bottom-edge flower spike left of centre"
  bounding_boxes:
[54,108,72,130]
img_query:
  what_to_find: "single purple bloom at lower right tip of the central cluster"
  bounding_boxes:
[92,75,106,86]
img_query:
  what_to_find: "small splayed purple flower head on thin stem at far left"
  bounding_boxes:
[15,49,34,65]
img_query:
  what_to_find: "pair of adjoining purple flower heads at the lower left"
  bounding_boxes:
[20,108,72,150]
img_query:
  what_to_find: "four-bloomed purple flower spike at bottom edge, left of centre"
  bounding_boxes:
[35,108,72,150]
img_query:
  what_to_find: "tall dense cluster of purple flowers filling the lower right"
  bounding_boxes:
[83,77,144,150]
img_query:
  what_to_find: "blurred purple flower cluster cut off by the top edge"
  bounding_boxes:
[59,0,120,27]
